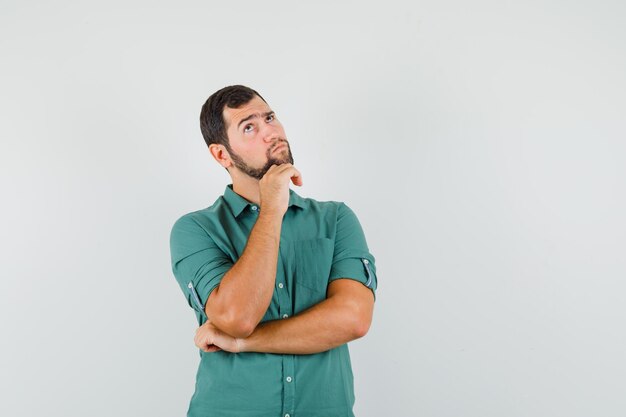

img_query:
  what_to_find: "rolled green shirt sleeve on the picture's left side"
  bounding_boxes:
[170,214,233,321]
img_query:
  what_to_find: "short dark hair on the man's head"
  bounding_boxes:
[200,85,267,151]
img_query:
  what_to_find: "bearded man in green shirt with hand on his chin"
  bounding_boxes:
[170,85,377,417]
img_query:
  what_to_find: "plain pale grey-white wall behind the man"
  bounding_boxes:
[0,0,626,417]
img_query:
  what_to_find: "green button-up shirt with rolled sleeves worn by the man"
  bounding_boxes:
[170,184,377,417]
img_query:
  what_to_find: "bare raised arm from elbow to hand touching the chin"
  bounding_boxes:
[205,164,302,338]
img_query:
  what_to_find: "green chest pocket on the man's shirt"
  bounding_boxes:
[294,238,334,294]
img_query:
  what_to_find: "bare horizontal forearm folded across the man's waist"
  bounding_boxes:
[238,297,362,354]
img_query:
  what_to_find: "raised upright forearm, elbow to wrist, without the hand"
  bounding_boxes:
[206,214,282,337]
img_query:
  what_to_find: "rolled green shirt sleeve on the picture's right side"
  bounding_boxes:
[329,203,378,299]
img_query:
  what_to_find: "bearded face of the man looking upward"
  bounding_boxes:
[223,96,293,180]
